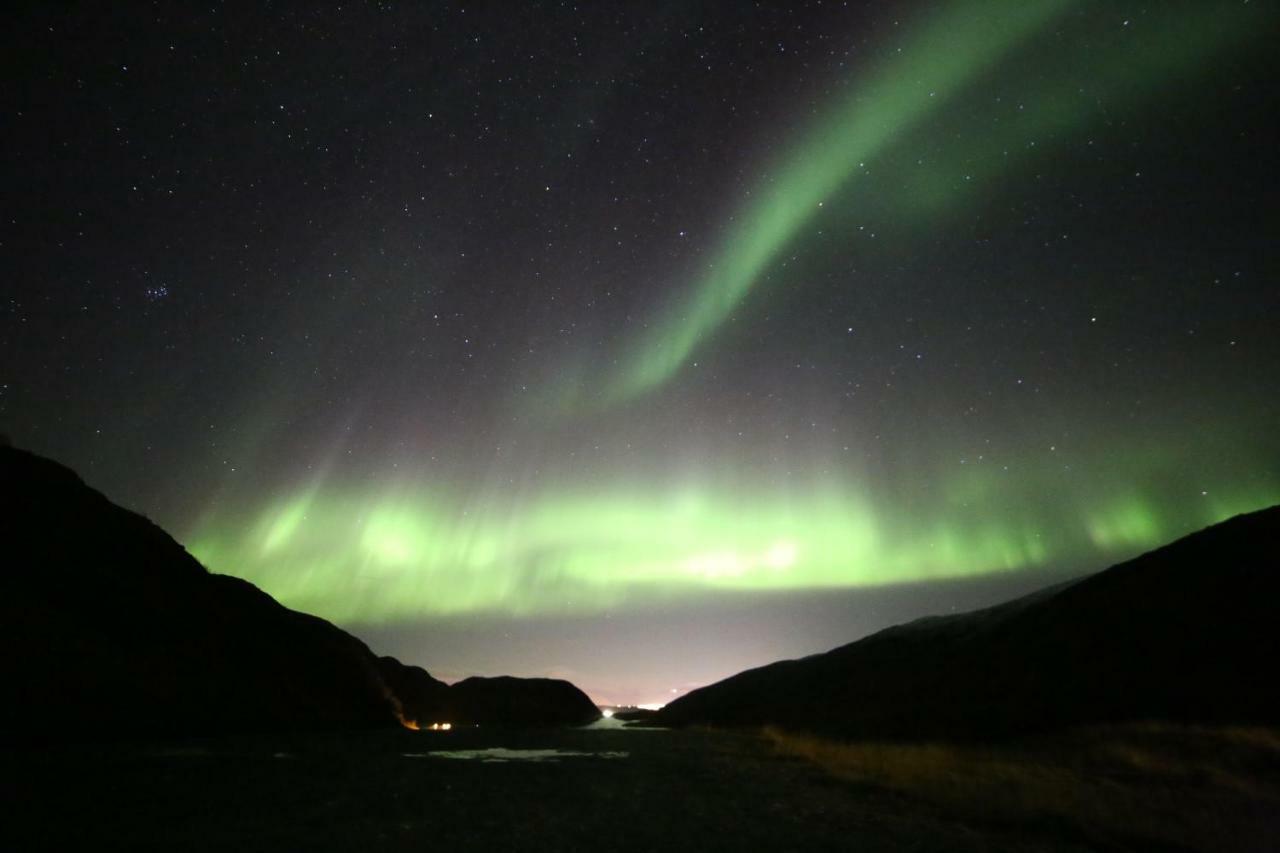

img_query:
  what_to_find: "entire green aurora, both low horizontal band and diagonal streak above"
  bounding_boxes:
[183,0,1280,625]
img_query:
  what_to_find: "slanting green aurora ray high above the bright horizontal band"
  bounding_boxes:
[578,0,1249,400]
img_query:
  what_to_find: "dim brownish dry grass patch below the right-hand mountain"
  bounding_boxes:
[764,724,1280,850]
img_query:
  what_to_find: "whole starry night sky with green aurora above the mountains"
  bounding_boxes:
[0,0,1280,703]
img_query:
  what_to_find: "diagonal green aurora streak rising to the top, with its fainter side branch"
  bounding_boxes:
[540,0,1257,418]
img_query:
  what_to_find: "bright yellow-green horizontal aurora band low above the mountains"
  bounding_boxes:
[188,448,1280,624]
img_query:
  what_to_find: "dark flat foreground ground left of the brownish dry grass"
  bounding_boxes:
[0,729,1280,853]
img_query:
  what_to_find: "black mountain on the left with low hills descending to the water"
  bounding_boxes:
[0,447,594,740]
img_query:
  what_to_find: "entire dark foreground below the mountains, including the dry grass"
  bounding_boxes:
[10,727,1280,852]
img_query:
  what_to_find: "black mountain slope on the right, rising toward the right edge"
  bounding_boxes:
[658,507,1280,738]
